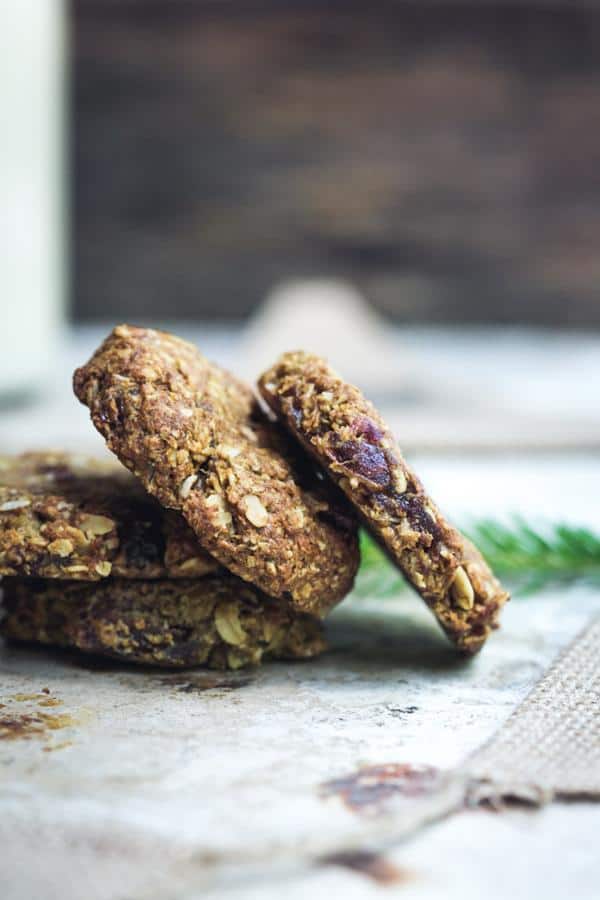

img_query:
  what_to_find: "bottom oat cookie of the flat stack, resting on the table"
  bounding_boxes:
[0,573,325,669]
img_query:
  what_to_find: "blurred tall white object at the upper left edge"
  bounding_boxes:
[0,0,65,398]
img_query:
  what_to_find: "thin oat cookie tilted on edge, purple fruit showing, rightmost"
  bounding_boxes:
[259,352,508,653]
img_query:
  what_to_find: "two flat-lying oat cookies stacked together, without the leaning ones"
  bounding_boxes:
[0,453,323,668]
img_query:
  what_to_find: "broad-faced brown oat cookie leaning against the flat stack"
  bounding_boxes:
[73,325,358,615]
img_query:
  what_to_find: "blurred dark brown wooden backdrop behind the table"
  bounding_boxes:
[71,0,600,326]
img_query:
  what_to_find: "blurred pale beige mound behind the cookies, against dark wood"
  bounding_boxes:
[237,279,413,395]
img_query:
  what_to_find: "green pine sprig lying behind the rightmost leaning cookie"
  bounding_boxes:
[355,517,600,597]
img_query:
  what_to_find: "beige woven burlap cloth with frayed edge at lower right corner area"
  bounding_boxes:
[464,618,600,803]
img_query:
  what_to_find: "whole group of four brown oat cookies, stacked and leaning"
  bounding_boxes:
[0,326,507,668]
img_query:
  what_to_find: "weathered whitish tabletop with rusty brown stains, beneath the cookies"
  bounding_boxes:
[0,326,600,900]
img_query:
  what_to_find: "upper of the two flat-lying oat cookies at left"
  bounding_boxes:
[0,452,218,581]
